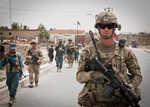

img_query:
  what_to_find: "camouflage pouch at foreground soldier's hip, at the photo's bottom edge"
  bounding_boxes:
[78,87,96,107]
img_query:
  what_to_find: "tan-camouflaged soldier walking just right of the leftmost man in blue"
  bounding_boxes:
[25,41,43,88]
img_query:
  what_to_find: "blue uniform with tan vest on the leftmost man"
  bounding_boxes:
[0,53,23,97]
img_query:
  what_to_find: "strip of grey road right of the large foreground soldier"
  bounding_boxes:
[134,49,150,107]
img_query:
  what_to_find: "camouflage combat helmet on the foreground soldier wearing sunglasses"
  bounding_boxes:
[94,11,121,30]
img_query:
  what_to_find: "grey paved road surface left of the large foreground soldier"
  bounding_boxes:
[0,63,82,107]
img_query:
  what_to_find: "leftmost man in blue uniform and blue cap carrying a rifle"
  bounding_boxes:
[0,43,23,106]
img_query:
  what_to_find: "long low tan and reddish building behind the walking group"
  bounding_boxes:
[0,29,85,44]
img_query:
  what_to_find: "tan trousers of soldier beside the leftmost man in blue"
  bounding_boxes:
[28,64,40,83]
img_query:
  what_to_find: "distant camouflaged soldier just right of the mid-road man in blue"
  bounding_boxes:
[66,39,75,67]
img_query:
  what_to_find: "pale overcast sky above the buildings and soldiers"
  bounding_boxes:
[0,0,150,33]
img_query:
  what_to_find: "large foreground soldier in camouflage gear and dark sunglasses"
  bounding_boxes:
[76,11,142,107]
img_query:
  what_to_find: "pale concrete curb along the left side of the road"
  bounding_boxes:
[0,63,55,100]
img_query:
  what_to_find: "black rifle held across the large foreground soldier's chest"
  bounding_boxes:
[89,30,141,107]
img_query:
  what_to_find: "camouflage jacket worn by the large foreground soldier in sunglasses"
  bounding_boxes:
[76,44,142,102]
